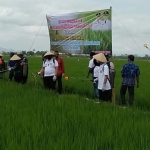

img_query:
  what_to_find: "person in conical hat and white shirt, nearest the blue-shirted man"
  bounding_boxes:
[93,53,112,101]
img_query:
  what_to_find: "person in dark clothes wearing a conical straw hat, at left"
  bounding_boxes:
[9,54,22,83]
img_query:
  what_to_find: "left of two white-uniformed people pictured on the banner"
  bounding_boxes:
[92,13,102,31]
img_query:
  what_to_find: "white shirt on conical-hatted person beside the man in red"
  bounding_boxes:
[43,59,58,77]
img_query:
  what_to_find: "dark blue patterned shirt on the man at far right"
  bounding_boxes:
[121,62,140,86]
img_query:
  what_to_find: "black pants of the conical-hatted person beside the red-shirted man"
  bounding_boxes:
[43,76,56,90]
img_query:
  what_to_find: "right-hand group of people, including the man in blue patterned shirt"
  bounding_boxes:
[87,52,140,107]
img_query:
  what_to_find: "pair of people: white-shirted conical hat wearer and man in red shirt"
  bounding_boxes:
[38,51,65,94]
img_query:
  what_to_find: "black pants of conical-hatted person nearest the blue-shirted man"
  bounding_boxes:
[99,89,112,102]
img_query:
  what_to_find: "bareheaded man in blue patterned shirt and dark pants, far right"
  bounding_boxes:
[120,55,140,106]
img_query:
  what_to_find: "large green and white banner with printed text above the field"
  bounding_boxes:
[46,9,112,54]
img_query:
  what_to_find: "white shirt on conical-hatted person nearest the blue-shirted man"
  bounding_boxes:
[98,64,111,90]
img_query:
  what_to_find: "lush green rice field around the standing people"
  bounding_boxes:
[0,57,150,150]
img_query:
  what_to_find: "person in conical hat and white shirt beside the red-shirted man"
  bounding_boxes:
[41,51,58,90]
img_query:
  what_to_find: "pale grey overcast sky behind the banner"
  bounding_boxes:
[0,0,150,55]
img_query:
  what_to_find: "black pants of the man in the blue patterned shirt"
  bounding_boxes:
[120,85,134,105]
